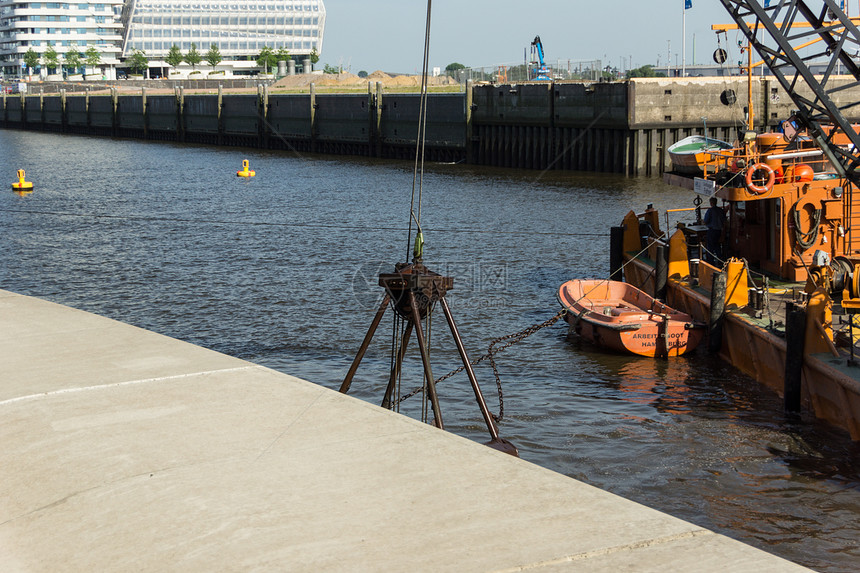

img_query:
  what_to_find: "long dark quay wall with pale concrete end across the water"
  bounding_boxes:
[6,77,860,175]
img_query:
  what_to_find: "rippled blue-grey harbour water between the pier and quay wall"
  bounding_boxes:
[0,130,860,572]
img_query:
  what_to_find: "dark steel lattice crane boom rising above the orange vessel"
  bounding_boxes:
[719,0,860,185]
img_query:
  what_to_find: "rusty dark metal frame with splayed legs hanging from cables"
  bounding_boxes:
[340,261,518,456]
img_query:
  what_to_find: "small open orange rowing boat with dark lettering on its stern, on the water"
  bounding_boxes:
[558,280,705,357]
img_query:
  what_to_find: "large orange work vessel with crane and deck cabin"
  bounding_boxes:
[610,0,860,440]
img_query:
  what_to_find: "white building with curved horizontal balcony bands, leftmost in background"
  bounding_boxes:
[0,0,123,77]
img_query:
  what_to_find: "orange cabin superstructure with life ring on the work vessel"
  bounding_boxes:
[676,133,860,281]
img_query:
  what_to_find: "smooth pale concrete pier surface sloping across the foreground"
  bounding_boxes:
[0,291,806,573]
